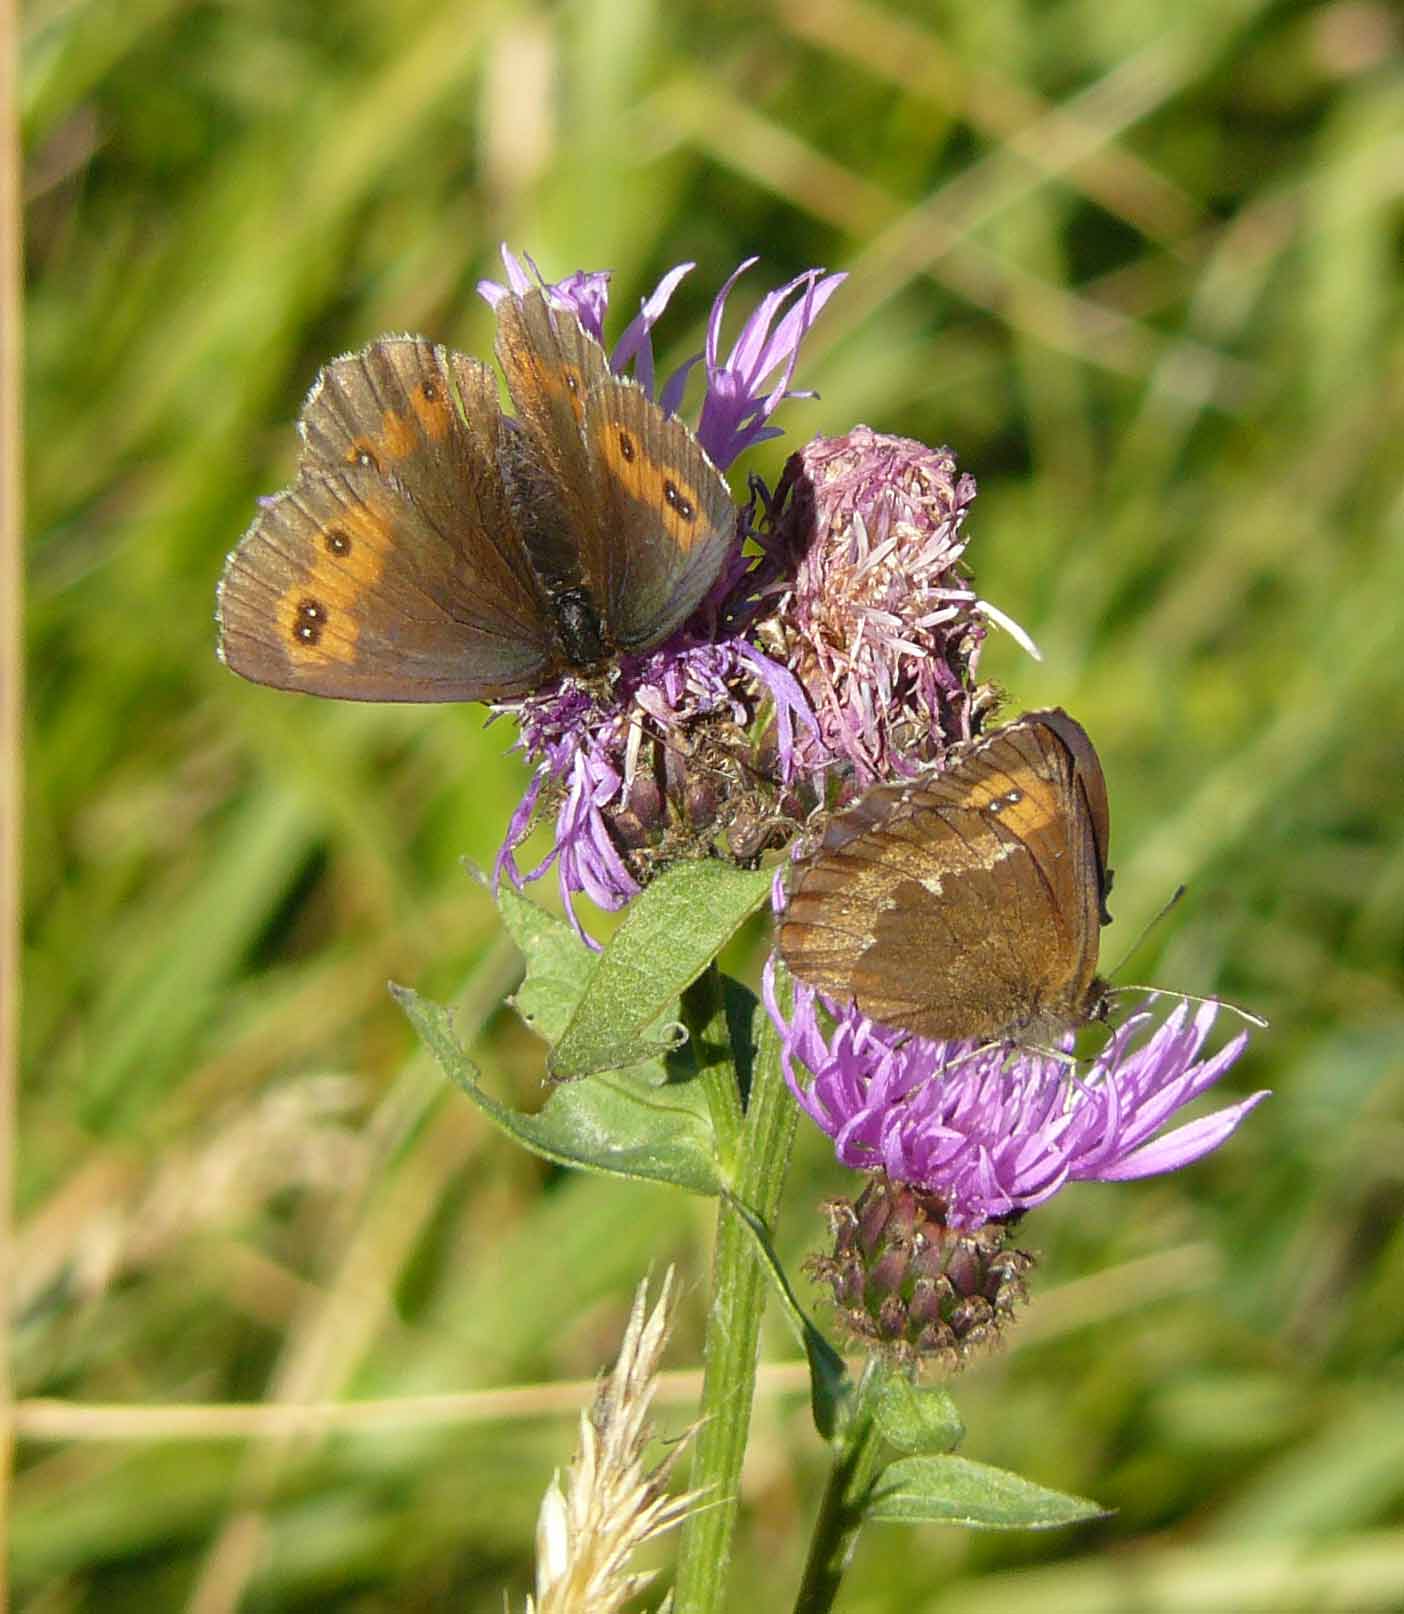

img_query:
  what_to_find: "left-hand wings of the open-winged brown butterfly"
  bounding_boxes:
[218,337,558,700]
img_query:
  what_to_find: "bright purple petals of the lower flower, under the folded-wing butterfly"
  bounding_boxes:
[765,960,1267,1228]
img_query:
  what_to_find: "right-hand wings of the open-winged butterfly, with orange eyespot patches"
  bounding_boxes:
[497,292,736,652]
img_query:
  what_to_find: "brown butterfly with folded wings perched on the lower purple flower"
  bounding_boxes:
[779,710,1112,1043]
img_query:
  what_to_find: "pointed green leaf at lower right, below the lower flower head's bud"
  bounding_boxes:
[863,1457,1107,1530]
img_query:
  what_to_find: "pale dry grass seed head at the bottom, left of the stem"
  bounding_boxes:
[526,1267,700,1614]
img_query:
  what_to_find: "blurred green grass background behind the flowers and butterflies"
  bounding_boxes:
[11,0,1404,1614]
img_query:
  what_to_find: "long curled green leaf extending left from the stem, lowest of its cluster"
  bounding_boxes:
[391,985,723,1194]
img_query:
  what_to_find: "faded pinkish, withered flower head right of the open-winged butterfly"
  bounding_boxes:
[757,426,1038,792]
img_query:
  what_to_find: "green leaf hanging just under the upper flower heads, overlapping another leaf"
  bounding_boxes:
[547,862,773,1081]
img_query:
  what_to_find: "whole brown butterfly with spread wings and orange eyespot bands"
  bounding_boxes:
[218,291,736,700]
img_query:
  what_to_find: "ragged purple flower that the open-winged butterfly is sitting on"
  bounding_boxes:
[478,249,844,939]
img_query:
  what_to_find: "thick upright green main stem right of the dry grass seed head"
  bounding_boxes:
[673,987,797,1614]
